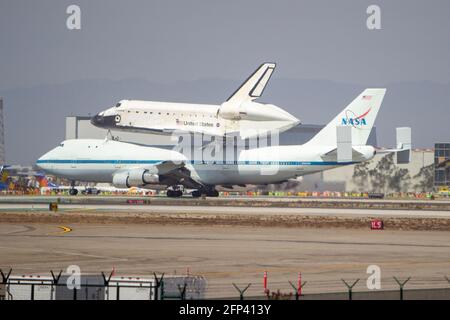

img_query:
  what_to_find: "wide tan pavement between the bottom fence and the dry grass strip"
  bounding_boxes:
[0,223,450,297]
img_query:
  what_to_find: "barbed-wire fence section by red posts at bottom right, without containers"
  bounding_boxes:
[208,277,450,300]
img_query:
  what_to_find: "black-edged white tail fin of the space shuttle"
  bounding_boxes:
[227,63,276,104]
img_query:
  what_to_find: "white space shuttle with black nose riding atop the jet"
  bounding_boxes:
[91,63,300,139]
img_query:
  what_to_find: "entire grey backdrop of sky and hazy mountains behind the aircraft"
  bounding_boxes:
[0,0,450,164]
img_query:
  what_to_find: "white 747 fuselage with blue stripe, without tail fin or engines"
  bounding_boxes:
[37,139,375,185]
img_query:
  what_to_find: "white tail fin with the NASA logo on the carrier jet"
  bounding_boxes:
[308,89,386,146]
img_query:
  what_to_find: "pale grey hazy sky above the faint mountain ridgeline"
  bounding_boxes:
[0,0,450,89]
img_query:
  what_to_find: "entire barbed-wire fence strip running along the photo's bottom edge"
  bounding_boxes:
[0,270,450,300]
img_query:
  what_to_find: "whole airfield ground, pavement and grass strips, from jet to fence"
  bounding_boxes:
[0,197,450,298]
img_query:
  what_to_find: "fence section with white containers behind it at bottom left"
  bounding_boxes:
[0,272,206,300]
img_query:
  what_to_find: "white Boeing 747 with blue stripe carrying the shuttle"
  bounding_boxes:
[37,89,411,197]
